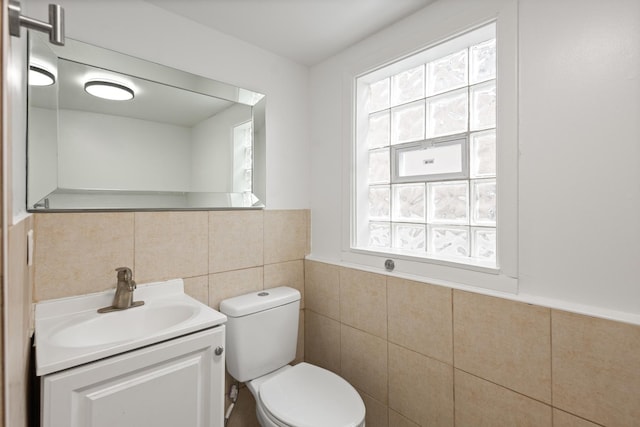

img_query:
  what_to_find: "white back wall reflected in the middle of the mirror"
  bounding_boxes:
[58,110,191,191]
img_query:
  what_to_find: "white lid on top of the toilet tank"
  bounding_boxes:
[220,286,300,317]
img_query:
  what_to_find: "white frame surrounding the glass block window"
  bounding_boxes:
[341,0,518,293]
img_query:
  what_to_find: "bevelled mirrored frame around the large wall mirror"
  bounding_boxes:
[25,31,266,212]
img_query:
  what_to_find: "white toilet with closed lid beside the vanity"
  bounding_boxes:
[220,286,365,427]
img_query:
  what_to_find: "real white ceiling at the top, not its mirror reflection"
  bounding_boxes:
[146,0,434,66]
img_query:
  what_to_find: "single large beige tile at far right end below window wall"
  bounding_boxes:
[551,311,640,426]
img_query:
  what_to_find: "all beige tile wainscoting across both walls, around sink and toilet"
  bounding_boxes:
[25,214,640,427]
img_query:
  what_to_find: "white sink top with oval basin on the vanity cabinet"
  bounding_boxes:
[35,279,227,376]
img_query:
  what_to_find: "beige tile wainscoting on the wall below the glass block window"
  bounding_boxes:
[305,260,640,427]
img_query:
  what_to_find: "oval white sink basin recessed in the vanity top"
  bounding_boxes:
[48,304,198,347]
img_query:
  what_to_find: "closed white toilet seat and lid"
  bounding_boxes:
[258,362,365,427]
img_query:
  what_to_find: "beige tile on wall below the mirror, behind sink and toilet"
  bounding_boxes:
[34,210,310,427]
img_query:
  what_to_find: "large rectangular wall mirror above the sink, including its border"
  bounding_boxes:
[27,31,266,212]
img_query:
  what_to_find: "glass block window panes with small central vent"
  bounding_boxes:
[353,24,498,268]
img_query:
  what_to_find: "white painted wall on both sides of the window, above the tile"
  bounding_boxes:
[310,0,640,323]
